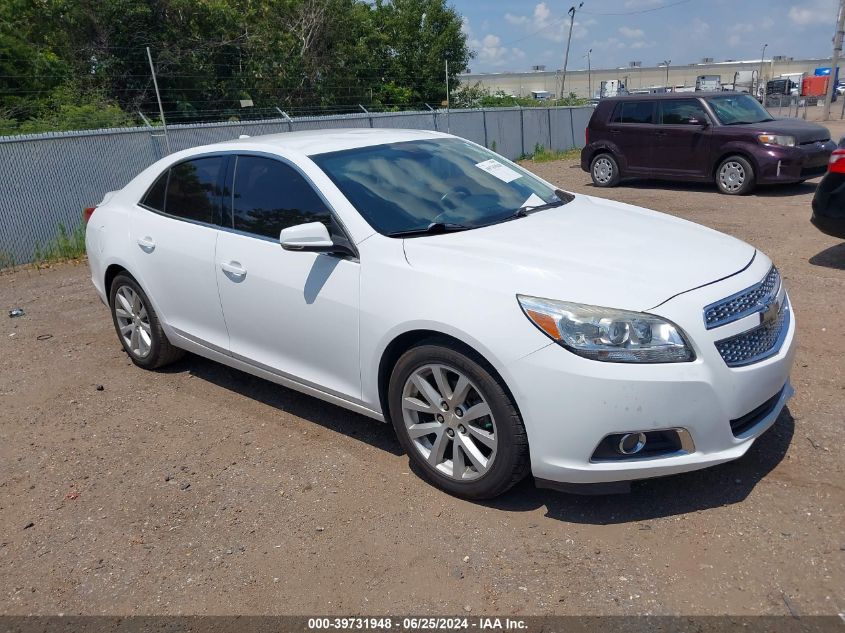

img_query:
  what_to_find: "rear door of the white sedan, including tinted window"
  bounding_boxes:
[130,156,229,351]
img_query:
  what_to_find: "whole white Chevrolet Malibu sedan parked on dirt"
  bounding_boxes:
[85,129,795,499]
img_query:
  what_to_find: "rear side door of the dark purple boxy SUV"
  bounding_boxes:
[607,99,656,176]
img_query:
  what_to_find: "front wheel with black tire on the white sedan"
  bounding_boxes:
[388,340,529,499]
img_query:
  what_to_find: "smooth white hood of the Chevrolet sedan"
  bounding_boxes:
[404,196,755,311]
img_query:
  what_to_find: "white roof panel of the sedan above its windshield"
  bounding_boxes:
[211,128,449,156]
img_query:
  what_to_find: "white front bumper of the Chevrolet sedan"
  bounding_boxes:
[508,257,795,484]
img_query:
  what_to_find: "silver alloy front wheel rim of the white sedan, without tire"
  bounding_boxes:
[402,364,498,481]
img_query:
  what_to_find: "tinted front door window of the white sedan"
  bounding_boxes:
[232,156,331,239]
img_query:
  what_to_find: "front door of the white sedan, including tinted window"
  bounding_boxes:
[216,156,361,401]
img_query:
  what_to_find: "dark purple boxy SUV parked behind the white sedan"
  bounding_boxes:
[581,92,836,195]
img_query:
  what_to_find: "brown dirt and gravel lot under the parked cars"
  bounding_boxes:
[0,126,845,614]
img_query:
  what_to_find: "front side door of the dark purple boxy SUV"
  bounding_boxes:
[652,98,712,178]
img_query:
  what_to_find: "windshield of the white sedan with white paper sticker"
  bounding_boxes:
[311,138,568,237]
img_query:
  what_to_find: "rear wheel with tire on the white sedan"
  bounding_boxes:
[109,273,185,369]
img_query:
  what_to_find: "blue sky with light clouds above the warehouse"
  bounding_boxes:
[458,0,839,72]
